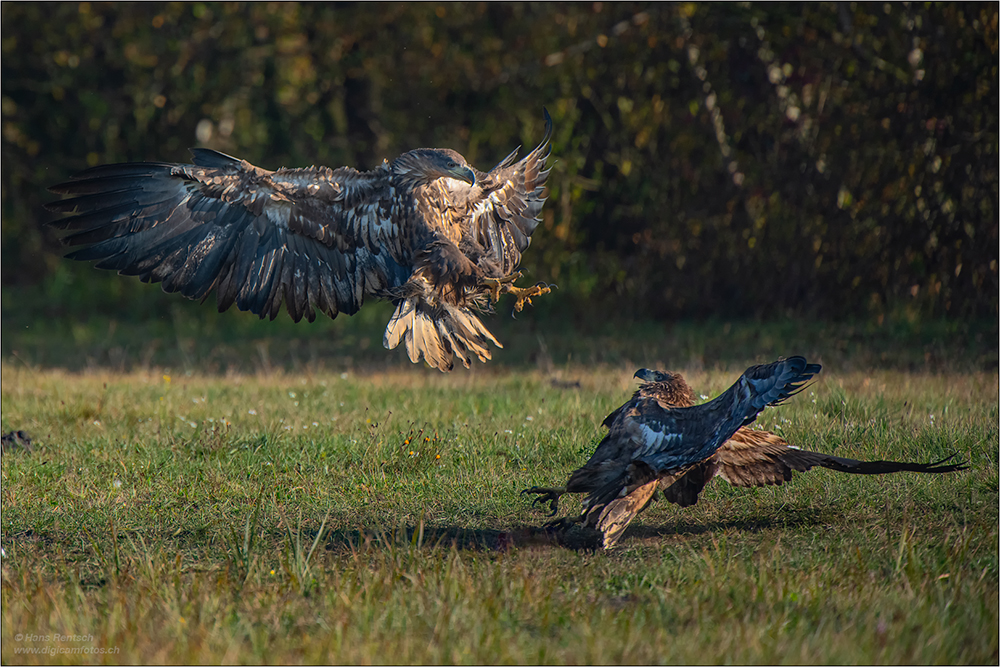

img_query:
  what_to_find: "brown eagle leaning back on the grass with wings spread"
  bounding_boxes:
[522,366,966,547]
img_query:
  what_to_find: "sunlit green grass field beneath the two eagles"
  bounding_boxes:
[0,311,1000,664]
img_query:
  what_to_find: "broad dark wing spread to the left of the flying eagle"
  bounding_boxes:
[46,148,411,322]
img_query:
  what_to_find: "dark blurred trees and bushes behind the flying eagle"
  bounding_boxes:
[2,2,998,359]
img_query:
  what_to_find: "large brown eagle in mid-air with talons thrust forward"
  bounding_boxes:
[46,111,552,371]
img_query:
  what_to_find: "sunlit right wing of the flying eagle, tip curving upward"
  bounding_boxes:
[469,110,552,275]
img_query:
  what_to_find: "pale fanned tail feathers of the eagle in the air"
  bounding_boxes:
[382,296,503,372]
